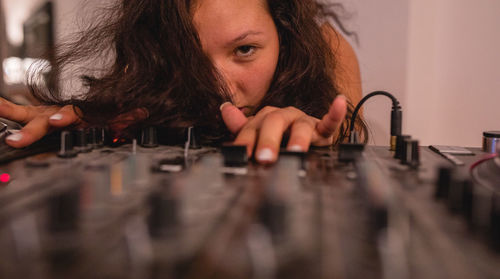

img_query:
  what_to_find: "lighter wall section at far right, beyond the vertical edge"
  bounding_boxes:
[406,0,500,146]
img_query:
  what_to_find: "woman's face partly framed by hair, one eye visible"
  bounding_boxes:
[193,0,279,115]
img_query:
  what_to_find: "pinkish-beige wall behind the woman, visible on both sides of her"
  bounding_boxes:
[2,0,500,146]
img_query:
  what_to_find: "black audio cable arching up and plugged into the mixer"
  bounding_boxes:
[349,91,403,150]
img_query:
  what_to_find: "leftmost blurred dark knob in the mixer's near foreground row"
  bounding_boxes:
[48,187,80,233]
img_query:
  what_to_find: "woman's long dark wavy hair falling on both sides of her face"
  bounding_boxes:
[28,0,365,142]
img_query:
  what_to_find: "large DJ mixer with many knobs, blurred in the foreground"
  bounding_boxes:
[0,122,500,279]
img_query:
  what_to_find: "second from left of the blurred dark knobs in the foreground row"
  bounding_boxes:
[148,186,179,238]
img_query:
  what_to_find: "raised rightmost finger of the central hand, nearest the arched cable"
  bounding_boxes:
[316,95,347,138]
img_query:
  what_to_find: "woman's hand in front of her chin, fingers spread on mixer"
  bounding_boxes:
[221,95,347,164]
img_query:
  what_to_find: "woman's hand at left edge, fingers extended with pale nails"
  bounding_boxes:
[0,98,80,148]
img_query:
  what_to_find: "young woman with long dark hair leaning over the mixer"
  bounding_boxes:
[0,0,364,163]
